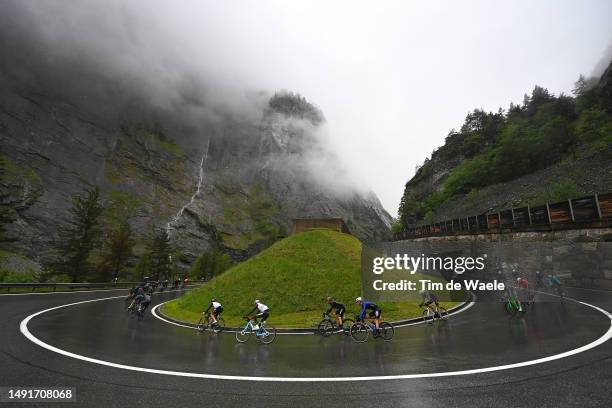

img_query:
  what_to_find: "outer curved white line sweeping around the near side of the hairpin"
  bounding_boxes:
[19,296,612,382]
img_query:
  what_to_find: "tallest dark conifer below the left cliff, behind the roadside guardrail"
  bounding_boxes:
[53,187,104,282]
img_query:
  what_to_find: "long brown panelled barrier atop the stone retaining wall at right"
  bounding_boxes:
[393,193,612,241]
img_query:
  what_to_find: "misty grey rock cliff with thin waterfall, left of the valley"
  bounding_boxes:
[0,6,391,268]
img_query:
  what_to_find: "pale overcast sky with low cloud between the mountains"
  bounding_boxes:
[9,0,612,216]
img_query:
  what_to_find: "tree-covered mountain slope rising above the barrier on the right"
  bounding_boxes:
[399,59,612,225]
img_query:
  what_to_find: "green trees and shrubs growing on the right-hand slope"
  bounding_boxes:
[399,67,612,225]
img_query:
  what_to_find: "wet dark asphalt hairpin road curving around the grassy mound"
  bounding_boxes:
[0,289,612,407]
